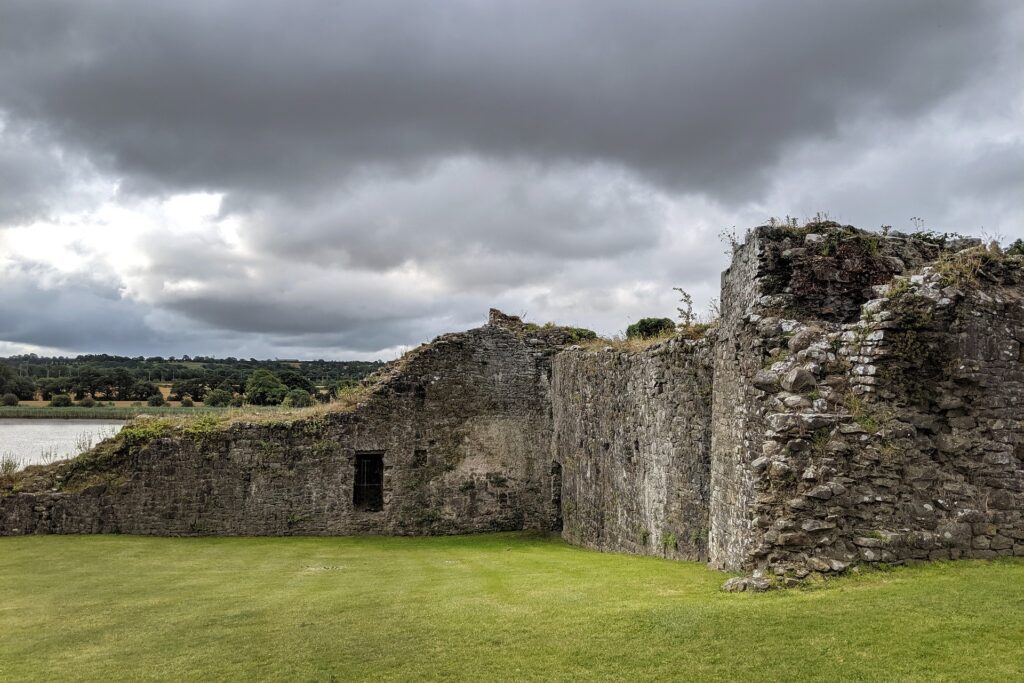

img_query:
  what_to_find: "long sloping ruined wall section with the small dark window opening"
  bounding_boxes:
[0,314,571,535]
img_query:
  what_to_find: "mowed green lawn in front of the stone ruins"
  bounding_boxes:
[0,535,1024,681]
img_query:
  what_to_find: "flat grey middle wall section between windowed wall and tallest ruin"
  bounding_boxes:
[553,339,712,560]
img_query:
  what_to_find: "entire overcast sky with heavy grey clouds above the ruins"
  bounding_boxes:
[0,0,1024,358]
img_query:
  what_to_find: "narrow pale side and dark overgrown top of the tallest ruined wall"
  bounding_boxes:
[710,224,939,570]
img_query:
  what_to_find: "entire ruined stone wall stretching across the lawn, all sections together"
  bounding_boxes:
[0,223,1024,590]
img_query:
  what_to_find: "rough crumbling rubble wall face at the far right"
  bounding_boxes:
[745,255,1024,581]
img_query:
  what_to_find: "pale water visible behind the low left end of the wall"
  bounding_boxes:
[0,420,125,466]
